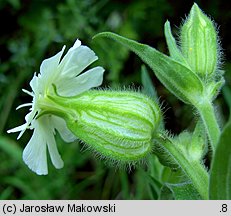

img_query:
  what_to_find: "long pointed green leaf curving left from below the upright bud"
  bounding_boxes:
[94,32,204,105]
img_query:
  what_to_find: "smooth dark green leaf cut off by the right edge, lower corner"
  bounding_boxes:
[209,120,231,200]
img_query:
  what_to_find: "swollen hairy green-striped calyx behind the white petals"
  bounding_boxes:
[51,91,161,162]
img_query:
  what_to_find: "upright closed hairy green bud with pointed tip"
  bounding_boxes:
[181,4,219,78]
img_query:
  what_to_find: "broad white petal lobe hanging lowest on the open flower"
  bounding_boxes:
[23,123,48,175]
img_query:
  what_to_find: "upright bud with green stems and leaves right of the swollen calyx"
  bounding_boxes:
[95,4,230,199]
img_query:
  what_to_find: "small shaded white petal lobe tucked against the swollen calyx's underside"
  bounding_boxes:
[52,116,77,142]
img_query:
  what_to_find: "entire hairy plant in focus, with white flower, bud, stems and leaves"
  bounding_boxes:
[4,1,231,199]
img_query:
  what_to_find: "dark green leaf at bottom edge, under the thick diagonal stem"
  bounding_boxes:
[161,182,201,200]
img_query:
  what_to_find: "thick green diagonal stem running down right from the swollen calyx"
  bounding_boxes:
[154,136,209,200]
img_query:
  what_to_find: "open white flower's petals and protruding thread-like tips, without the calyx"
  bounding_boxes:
[7,40,104,175]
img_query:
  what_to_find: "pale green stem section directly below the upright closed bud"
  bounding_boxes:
[196,100,221,152]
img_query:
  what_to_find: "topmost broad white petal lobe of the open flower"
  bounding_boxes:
[59,46,98,77]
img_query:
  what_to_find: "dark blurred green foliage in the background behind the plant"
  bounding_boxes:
[0,0,231,199]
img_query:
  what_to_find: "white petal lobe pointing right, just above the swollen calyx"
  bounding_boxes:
[57,67,104,97]
